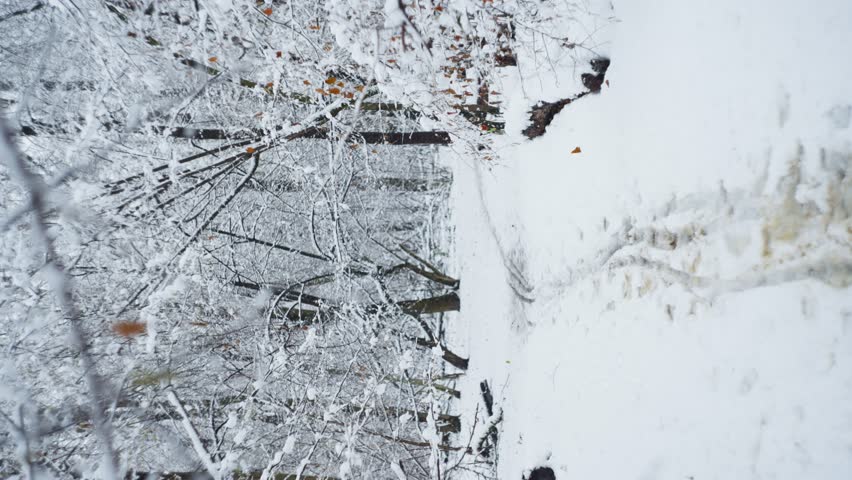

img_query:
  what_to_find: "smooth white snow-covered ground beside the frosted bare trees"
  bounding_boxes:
[447,0,852,479]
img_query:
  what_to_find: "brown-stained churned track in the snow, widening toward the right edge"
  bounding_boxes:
[543,160,852,300]
